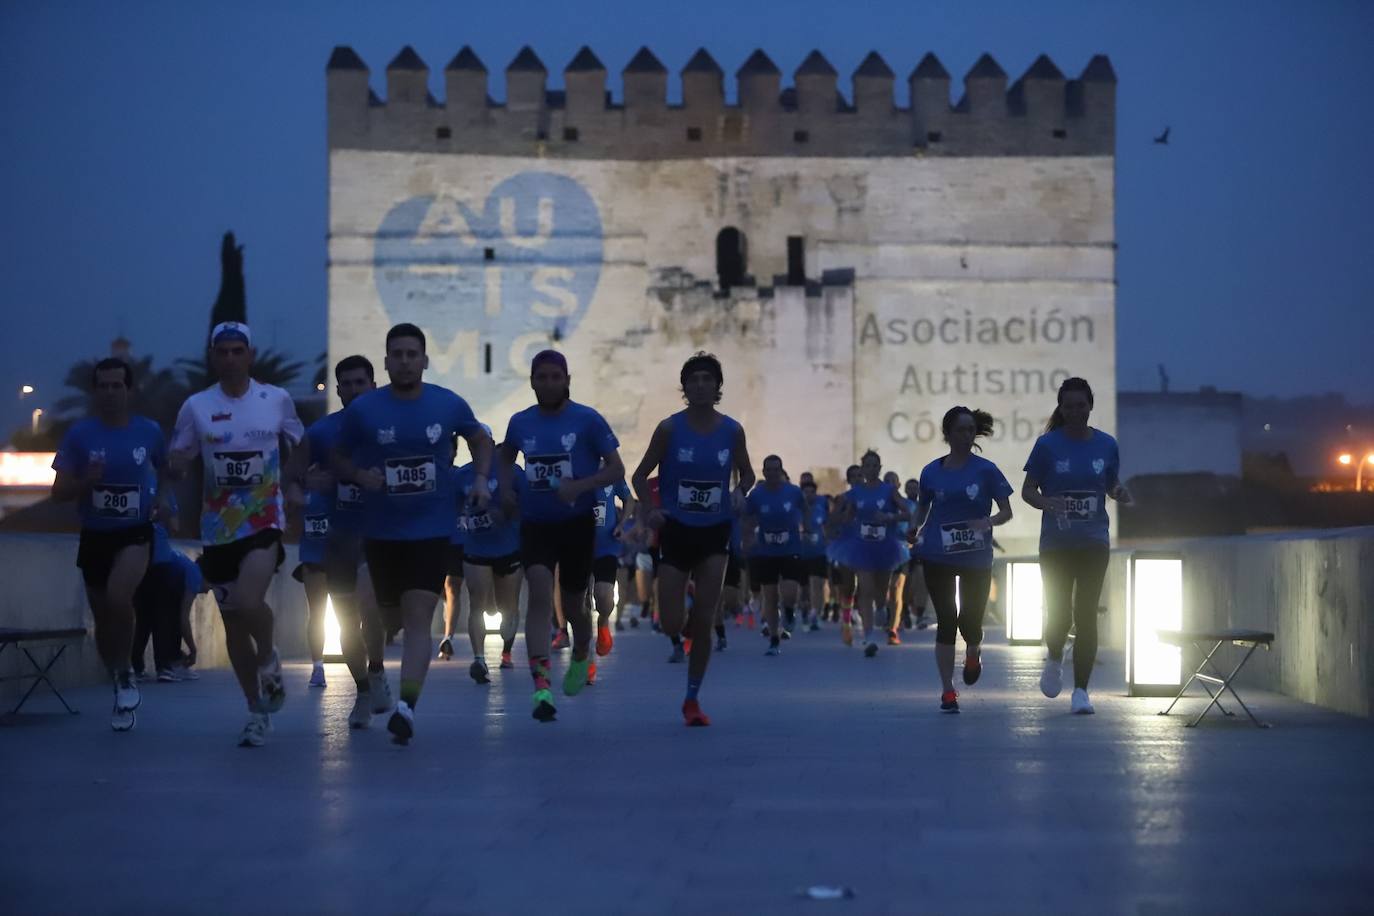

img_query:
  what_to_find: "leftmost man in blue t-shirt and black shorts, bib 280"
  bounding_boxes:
[52,357,168,732]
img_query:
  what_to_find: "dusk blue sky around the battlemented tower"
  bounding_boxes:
[0,0,1374,439]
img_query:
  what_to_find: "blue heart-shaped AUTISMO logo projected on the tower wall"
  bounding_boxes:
[372,172,605,416]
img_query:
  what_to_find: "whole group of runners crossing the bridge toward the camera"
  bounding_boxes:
[54,321,1129,747]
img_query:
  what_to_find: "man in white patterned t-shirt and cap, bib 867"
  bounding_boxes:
[170,321,305,747]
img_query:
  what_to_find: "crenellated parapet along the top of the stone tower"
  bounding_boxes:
[326,47,1116,159]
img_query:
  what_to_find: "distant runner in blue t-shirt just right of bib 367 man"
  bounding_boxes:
[745,455,811,655]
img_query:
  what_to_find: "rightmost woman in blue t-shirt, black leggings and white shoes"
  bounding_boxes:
[1021,378,1131,715]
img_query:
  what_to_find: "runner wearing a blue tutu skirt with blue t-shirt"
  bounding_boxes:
[831,449,908,658]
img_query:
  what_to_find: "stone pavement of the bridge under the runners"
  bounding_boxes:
[0,626,1374,916]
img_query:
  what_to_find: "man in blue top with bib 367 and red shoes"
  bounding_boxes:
[632,353,754,725]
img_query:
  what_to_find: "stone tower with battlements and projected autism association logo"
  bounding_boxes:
[327,47,1116,549]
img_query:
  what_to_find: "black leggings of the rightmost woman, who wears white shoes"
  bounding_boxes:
[1040,544,1109,689]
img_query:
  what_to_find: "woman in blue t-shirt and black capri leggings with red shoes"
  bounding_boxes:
[916,407,1011,713]
